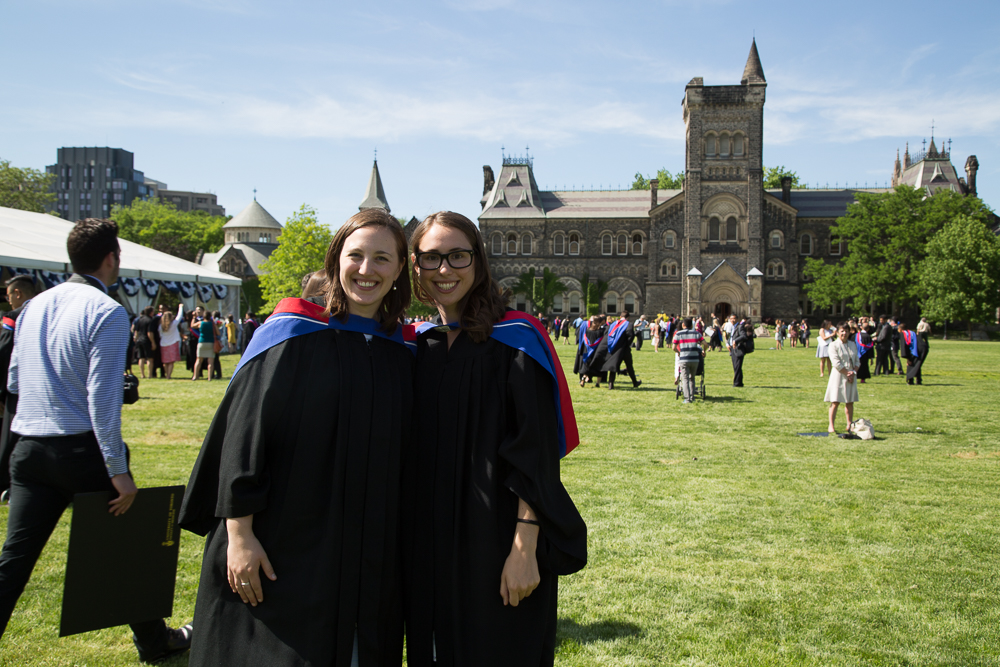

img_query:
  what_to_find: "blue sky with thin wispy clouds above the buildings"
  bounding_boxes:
[0,0,1000,227]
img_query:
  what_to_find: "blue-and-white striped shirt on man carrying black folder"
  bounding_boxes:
[7,276,129,476]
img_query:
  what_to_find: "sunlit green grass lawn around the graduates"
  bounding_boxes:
[0,339,1000,666]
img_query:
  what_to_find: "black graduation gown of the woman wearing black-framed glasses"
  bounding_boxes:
[403,332,587,667]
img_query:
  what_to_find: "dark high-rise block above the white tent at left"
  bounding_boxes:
[45,146,151,220]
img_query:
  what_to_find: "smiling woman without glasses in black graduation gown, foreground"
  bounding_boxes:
[180,209,414,667]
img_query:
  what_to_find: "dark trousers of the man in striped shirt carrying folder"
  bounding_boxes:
[0,433,167,650]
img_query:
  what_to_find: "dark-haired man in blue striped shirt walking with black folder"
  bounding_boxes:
[0,218,191,661]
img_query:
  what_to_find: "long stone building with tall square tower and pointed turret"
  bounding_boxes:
[479,42,978,319]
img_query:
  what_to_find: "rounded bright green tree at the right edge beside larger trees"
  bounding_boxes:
[919,215,1000,334]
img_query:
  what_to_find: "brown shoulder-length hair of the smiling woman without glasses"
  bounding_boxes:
[323,208,411,335]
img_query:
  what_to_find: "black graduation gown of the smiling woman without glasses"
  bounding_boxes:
[180,330,414,667]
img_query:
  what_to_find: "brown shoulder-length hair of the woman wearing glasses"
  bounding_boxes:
[410,211,510,343]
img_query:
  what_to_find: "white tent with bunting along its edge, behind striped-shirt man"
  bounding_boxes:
[0,207,242,314]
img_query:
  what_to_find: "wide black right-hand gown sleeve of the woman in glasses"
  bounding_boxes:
[499,352,587,575]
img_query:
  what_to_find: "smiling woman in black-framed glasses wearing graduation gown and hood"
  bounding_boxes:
[403,212,587,667]
